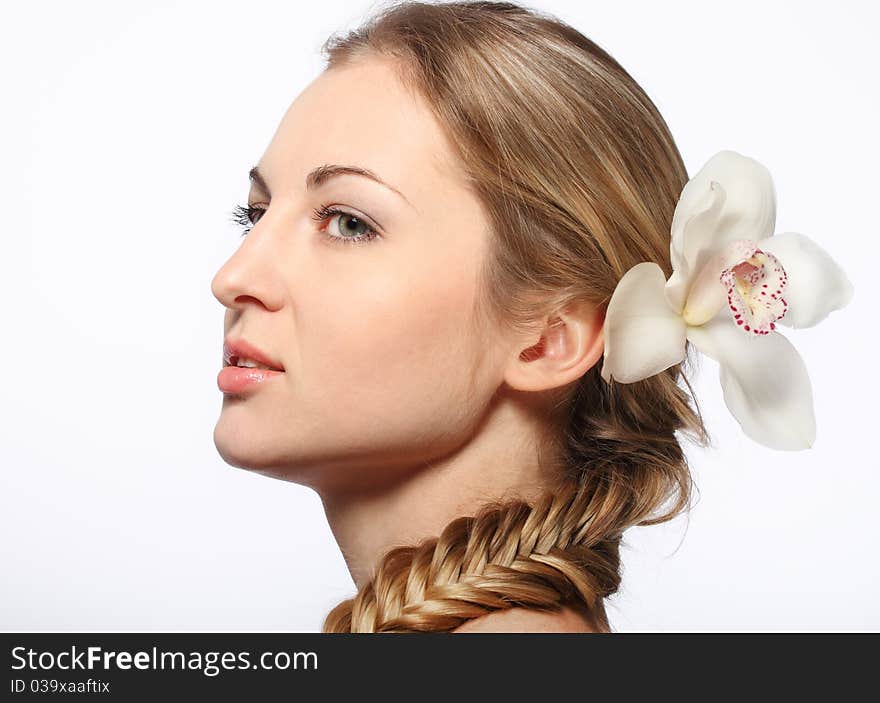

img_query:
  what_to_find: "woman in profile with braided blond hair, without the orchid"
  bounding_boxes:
[212,2,848,632]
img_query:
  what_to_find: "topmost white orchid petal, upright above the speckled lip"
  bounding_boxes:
[665,149,776,312]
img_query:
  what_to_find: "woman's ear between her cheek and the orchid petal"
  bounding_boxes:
[504,304,605,391]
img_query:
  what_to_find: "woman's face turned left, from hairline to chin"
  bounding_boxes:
[211,59,508,489]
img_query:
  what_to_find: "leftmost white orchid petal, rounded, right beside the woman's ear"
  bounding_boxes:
[602,261,687,383]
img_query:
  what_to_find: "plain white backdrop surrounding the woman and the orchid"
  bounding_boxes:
[0,0,880,632]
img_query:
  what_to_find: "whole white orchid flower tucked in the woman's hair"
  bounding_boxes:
[602,150,853,450]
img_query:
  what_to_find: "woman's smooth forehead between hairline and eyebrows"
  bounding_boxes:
[254,58,463,200]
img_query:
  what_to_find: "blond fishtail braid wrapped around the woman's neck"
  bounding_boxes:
[323,474,625,632]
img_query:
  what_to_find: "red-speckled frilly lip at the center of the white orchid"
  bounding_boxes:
[720,242,788,335]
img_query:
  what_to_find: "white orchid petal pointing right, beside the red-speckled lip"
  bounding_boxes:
[758,232,854,328]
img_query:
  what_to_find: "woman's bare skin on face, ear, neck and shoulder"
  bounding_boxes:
[211,58,604,631]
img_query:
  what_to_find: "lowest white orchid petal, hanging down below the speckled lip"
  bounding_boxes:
[687,311,816,450]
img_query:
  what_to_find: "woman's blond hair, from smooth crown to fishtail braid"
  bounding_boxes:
[322,2,711,632]
